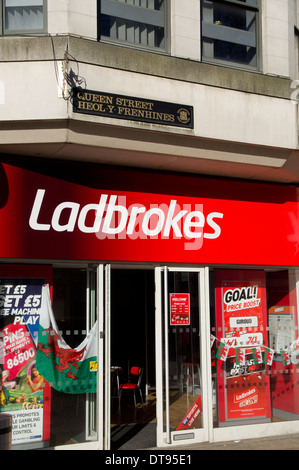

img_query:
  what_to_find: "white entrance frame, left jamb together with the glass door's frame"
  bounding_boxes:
[102,263,213,450]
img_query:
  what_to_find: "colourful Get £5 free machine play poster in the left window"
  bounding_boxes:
[0,269,50,446]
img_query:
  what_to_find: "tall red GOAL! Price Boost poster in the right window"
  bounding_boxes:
[216,270,271,423]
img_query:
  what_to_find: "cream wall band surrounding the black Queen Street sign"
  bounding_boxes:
[0,56,297,148]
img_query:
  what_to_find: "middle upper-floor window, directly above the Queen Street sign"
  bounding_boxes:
[99,0,168,52]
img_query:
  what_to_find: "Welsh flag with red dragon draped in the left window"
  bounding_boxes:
[36,285,98,393]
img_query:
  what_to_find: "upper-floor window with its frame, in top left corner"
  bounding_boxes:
[0,0,47,34]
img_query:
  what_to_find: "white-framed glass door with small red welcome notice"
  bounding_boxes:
[155,267,212,447]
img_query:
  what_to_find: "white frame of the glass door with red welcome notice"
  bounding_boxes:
[155,266,213,447]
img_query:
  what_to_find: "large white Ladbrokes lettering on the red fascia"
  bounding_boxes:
[29,189,223,250]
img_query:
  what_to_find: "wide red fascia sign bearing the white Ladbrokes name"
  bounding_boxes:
[0,164,299,266]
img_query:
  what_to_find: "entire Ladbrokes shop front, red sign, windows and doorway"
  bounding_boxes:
[0,159,299,449]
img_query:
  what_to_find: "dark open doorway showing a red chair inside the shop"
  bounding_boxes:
[111,269,156,449]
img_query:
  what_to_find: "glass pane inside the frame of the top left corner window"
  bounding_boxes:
[5,0,44,31]
